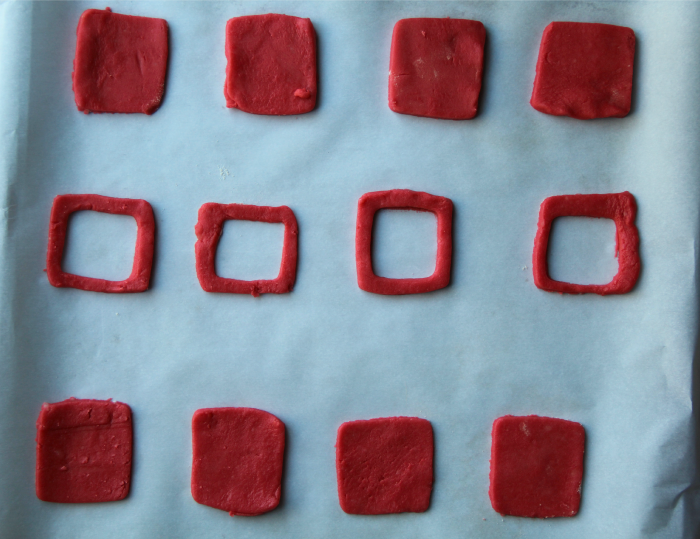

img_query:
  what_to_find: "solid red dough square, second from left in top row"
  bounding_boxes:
[224,13,317,116]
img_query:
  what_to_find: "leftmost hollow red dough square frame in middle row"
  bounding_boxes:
[46,195,156,292]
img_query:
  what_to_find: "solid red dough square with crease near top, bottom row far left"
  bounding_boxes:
[36,398,132,503]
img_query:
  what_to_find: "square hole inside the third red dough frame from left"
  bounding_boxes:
[372,210,437,279]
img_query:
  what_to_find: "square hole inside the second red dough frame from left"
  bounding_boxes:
[216,220,284,281]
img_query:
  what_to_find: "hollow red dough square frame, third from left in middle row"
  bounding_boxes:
[355,189,453,295]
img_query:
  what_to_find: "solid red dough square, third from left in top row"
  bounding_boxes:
[389,19,486,120]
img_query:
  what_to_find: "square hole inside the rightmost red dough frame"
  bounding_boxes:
[547,217,619,284]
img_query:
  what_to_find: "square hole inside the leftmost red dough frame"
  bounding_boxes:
[62,211,137,281]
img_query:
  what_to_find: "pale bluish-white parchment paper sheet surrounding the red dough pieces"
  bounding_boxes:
[0,0,700,539]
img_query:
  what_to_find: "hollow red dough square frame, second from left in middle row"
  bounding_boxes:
[194,202,299,296]
